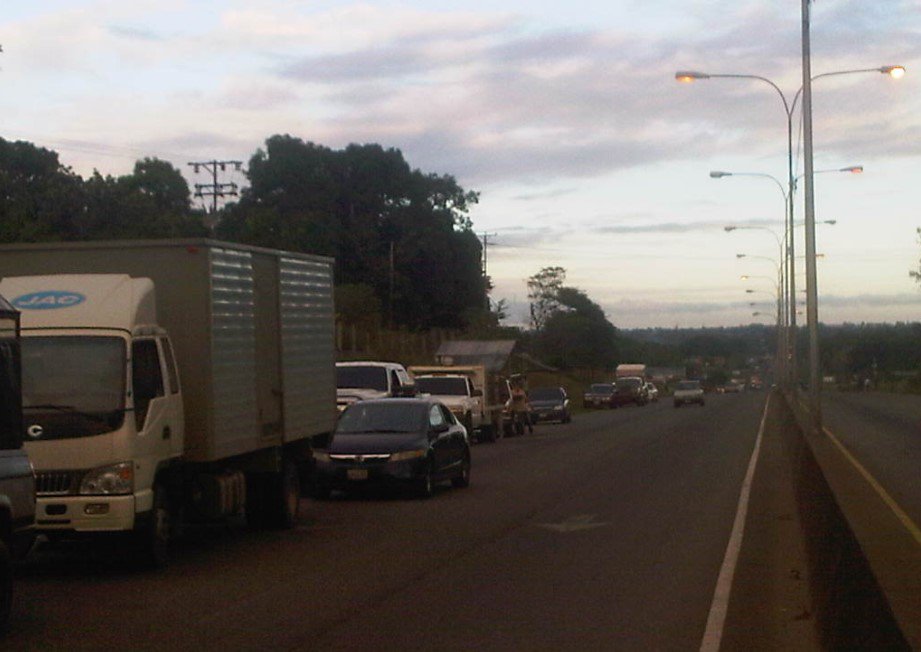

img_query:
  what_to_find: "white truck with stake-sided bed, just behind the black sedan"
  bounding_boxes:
[409,365,504,441]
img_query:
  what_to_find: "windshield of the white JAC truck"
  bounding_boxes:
[22,335,127,441]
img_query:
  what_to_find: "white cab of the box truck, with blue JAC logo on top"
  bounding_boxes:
[0,274,184,561]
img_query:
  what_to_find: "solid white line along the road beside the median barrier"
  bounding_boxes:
[700,396,771,652]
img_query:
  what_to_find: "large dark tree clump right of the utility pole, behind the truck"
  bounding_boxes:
[217,136,488,329]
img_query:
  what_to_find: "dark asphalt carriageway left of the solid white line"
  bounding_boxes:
[9,393,766,651]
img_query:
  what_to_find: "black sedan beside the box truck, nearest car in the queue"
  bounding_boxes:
[313,398,470,498]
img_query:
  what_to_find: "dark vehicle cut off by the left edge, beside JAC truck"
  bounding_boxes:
[0,297,35,633]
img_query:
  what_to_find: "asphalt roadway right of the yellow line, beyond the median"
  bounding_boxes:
[822,391,921,526]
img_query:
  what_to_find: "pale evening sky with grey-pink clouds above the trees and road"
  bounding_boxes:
[0,0,921,328]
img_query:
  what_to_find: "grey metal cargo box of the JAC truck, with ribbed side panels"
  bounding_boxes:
[0,239,336,462]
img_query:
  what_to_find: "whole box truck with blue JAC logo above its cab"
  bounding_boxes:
[0,240,336,565]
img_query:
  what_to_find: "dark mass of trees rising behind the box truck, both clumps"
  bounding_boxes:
[0,135,495,330]
